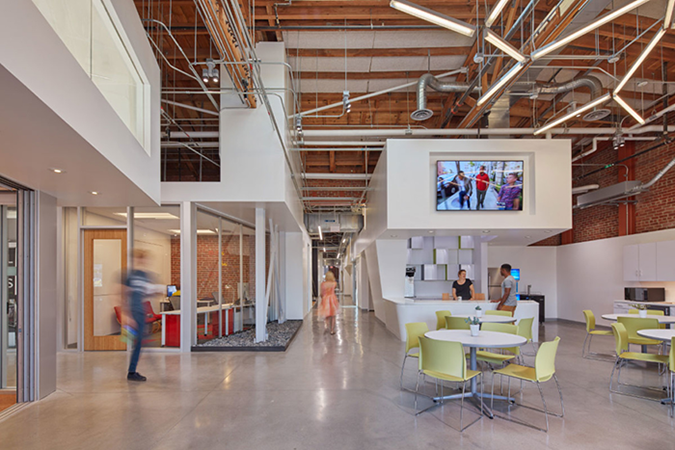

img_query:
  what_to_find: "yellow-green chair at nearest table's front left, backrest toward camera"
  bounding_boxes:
[415,336,483,432]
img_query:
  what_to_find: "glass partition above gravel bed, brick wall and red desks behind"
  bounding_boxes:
[196,210,255,345]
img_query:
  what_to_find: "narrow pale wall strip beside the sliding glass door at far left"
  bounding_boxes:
[36,192,58,399]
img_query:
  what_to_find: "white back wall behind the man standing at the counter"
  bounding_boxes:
[488,246,562,319]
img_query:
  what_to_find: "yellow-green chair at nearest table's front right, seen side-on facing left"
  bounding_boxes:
[491,337,565,433]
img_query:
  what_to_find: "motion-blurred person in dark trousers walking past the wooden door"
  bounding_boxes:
[124,250,162,381]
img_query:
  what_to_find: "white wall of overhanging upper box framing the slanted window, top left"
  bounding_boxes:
[0,0,160,205]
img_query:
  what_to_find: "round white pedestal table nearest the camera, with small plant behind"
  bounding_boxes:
[425,328,527,418]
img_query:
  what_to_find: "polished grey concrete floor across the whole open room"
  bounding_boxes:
[0,309,675,450]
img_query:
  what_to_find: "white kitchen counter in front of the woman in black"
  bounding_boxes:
[384,298,539,342]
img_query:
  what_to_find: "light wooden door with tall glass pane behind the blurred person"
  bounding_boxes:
[84,230,127,350]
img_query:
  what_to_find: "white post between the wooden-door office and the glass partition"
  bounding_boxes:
[180,202,197,353]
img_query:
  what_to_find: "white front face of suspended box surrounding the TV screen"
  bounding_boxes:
[386,139,572,234]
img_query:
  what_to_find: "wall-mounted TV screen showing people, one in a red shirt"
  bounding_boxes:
[436,161,523,211]
